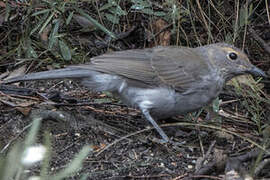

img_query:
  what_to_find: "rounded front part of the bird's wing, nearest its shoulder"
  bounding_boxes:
[151,47,209,92]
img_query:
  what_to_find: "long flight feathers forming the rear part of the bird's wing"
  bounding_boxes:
[71,49,158,85]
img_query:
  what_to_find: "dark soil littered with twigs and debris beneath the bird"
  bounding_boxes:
[0,80,270,179]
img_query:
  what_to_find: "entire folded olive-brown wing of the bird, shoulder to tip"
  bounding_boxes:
[72,46,211,92]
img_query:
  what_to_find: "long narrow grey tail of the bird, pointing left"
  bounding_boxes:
[4,67,96,84]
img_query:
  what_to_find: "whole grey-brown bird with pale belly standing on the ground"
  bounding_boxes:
[5,43,266,142]
